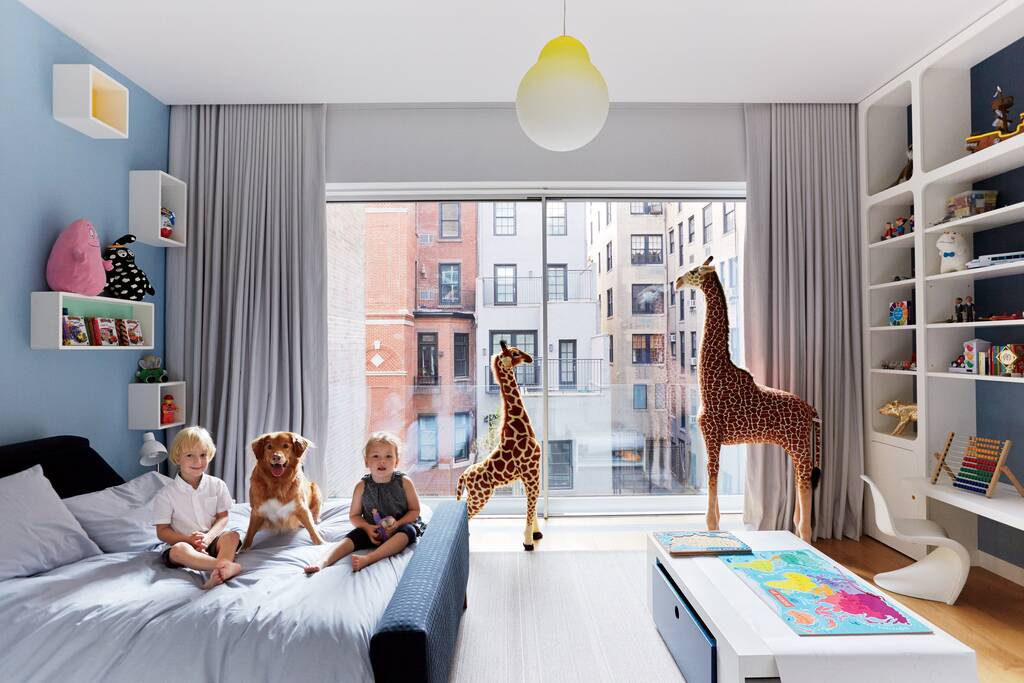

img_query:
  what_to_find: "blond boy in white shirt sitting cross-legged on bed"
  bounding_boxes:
[153,427,242,589]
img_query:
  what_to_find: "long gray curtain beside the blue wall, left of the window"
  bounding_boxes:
[164,104,328,501]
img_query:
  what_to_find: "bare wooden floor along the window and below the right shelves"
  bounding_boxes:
[470,515,1024,683]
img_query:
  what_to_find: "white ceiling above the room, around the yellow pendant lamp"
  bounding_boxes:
[23,0,1001,104]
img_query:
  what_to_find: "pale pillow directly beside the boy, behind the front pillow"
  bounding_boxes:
[65,472,171,553]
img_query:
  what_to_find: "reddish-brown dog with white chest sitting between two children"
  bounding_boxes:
[242,432,324,550]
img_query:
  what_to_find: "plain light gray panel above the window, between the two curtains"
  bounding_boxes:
[327,104,745,183]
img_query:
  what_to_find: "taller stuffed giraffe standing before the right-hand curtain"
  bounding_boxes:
[676,257,821,542]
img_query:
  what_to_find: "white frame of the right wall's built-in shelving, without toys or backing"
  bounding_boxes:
[858,0,1024,559]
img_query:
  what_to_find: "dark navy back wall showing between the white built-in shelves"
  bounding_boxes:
[971,39,1024,565]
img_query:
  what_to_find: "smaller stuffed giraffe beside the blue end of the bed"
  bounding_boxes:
[455,341,544,550]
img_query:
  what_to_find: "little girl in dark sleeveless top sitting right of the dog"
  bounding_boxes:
[305,432,425,573]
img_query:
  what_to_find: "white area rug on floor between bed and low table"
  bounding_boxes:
[451,542,683,683]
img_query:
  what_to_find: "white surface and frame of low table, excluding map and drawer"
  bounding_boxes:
[644,530,978,683]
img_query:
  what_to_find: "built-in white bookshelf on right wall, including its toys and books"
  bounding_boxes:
[859,2,1024,575]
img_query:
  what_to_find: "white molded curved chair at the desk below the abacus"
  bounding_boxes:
[860,474,971,605]
